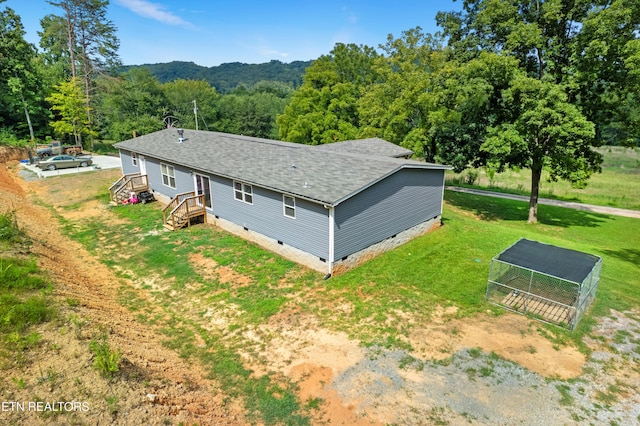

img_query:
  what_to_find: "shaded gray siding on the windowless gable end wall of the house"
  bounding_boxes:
[334,169,444,261]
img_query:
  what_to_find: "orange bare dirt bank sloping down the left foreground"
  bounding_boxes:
[0,161,247,425]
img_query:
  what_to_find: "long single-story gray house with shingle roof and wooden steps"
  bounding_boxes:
[112,128,448,274]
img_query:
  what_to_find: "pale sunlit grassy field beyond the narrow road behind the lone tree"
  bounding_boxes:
[446,146,640,210]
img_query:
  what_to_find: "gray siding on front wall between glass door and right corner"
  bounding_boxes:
[211,176,329,259]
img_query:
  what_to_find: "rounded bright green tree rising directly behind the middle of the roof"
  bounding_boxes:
[276,43,378,145]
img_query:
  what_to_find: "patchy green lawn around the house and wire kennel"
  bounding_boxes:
[51,169,640,424]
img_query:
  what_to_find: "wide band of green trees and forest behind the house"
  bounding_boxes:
[0,0,640,222]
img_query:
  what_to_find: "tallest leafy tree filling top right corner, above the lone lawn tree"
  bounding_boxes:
[437,0,640,144]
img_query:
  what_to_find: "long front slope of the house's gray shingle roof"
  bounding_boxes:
[115,128,449,205]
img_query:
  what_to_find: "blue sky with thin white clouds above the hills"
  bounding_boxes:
[0,0,461,67]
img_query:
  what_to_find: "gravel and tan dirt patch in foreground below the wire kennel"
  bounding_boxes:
[331,311,640,426]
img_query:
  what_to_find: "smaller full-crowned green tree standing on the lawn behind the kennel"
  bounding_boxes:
[481,74,602,223]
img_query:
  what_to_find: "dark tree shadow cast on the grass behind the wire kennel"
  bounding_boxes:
[444,191,609,228]
